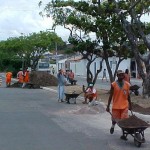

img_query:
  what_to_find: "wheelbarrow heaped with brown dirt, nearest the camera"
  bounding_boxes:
[111,111,150,147]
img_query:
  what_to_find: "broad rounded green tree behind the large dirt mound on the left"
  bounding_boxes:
[0,31,64,70]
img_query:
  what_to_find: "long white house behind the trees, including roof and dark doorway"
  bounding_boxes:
[57,56,138,78]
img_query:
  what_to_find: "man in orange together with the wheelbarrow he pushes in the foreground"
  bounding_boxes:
[106,70,148,146]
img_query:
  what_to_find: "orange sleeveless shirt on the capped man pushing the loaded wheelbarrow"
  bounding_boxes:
[112,81,130,109]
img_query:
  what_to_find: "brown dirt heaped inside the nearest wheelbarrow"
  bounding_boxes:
[118,115,149,128]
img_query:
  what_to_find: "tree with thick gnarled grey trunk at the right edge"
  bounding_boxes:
[106,0,150,96]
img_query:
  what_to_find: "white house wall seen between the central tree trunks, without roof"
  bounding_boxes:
[58,57,131,78]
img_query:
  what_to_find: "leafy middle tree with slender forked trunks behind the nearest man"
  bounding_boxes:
[40,0,131,82]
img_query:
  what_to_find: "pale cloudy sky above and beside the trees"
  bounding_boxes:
[0,0,150,41]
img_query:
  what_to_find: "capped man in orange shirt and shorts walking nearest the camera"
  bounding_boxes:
[106,70,131,140]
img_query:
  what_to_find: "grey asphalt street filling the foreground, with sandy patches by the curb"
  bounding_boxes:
[0,74,150,150]
